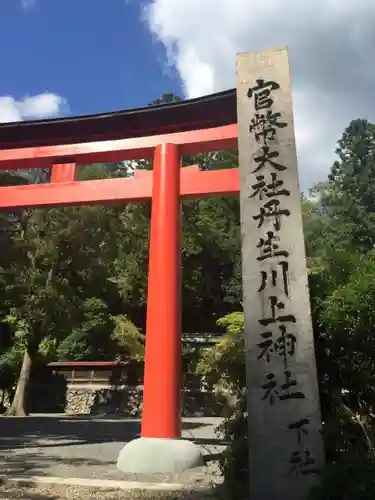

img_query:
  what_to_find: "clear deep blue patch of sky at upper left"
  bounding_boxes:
[0,0,182,115]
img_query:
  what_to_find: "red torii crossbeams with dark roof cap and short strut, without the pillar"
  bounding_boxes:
[0,90,239,209]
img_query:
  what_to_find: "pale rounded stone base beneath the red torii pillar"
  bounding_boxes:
[117,437,204,474]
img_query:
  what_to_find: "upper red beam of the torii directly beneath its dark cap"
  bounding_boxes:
[0,124,237,170]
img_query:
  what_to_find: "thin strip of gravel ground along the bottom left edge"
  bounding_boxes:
[0,486,212,500]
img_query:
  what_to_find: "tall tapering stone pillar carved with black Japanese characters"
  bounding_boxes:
[237,49,324,500]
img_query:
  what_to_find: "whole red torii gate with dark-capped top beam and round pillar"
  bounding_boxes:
[0,90,239,472]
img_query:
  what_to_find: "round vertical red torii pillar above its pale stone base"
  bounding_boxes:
[141,144,181,438]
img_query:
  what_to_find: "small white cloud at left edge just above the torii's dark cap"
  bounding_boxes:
[0,92,68,123]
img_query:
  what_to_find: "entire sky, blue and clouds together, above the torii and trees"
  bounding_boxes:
[0,0,375,187]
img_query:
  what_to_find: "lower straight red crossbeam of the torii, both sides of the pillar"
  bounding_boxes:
[0,168,240,210]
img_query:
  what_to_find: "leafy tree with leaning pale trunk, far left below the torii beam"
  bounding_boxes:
[5,207,78,415]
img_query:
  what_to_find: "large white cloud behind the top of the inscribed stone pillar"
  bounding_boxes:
[144,0,375,188]
